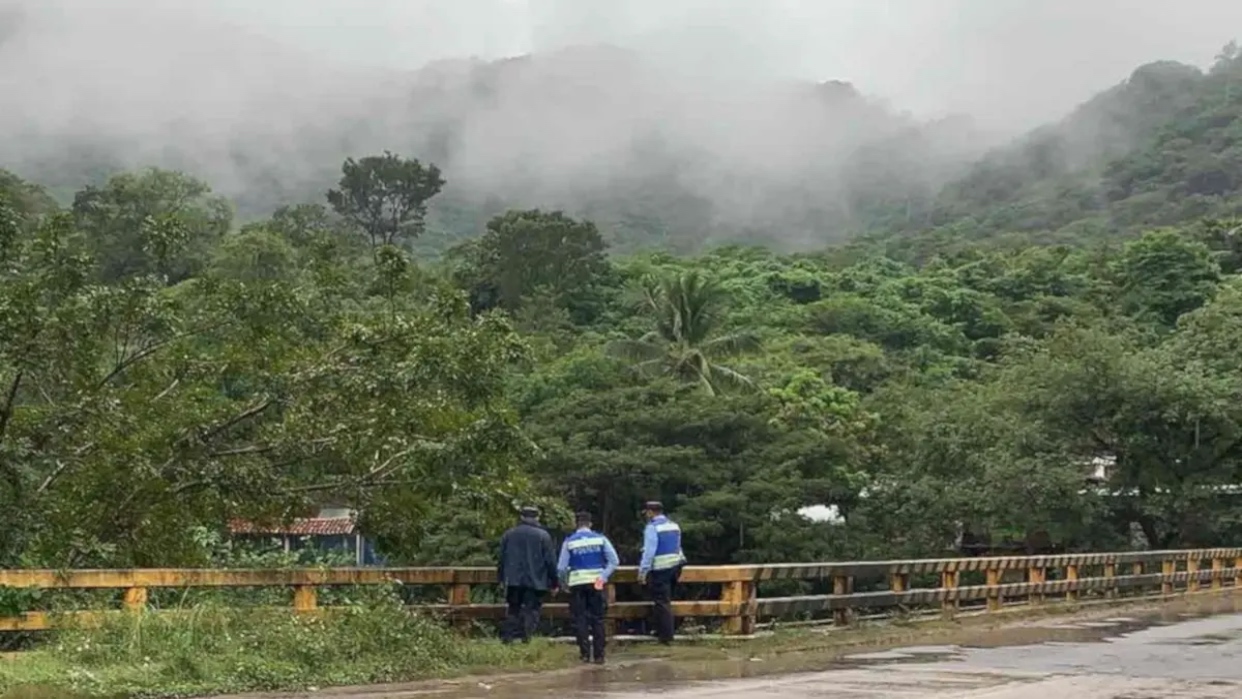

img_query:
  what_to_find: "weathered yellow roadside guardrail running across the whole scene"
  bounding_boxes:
[0,549,1242,634]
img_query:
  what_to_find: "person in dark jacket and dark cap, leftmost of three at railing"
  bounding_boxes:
[497,507,556,643]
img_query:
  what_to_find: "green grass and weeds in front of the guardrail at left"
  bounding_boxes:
[0,588,574,699]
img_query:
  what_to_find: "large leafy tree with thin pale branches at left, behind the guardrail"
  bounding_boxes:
[0,175,528,566]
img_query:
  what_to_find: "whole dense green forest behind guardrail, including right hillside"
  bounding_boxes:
[0,42,1242,567]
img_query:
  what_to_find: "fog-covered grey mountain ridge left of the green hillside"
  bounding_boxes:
[0,2,979,250]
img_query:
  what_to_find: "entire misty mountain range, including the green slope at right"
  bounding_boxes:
[0,6,1242,253]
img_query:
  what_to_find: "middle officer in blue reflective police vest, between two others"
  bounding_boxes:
[556,512,621,665]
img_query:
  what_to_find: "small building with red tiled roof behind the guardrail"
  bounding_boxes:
[229,508,384,566]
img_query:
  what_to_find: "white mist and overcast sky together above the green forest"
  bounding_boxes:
[0,0,1242,246]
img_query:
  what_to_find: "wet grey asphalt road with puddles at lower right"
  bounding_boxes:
[228,596,1242,699]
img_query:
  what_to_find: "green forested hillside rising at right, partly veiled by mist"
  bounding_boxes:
[874,43,1242,263]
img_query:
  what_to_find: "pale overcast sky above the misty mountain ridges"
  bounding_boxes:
[203,0,1242,125]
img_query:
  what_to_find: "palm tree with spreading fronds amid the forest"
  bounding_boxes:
[607,271,759,396]
